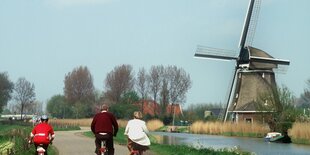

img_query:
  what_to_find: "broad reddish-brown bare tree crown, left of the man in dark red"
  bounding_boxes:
[64,66,95,103]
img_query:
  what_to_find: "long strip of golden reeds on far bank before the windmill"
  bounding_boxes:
[190,121,269,137]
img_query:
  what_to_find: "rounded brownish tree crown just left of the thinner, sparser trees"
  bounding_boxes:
[105,65,134,102]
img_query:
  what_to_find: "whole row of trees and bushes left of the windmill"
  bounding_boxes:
[0,64,192,118]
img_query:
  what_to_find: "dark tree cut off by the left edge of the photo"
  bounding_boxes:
[0,73,14,113]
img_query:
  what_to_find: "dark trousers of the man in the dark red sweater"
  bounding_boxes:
[95,134,114,155]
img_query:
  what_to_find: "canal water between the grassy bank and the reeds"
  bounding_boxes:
[152,132,310,155]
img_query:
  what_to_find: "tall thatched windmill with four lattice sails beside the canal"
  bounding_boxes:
[195,0,290,122]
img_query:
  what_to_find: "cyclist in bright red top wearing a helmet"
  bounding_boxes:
[29,115,55,155]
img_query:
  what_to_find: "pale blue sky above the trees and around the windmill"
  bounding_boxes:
[0,0,310,108]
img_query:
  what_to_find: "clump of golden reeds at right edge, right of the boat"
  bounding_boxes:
[288,122,310,144]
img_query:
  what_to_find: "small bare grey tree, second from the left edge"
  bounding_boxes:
[14,77,35,119]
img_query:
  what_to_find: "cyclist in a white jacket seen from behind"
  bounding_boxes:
[124,111,151,155]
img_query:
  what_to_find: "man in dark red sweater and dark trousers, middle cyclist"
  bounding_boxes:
[91,104,118,155]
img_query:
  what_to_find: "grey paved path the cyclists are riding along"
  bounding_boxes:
[53,127,155,155]
